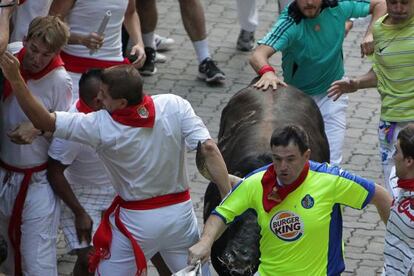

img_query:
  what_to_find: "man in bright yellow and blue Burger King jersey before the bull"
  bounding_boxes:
[189,125,391,276]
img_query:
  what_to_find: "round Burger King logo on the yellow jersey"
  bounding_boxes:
[270,211,304,241]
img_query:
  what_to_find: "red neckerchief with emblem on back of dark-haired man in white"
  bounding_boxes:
[111,95,155,128]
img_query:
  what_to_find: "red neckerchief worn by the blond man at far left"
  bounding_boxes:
[3,47,64,101]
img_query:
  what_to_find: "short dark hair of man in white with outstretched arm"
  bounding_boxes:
[101,65,143,106]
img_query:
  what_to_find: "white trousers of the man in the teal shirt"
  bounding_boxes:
[312,94,348,165]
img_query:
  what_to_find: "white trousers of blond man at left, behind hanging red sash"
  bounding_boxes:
[0,168,60,276]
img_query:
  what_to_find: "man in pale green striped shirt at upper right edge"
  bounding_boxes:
[328,0,414,196]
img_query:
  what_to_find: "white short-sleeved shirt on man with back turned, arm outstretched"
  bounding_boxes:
[54,94,210,200]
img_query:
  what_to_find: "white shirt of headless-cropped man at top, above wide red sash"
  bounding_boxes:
[63,0,128,61]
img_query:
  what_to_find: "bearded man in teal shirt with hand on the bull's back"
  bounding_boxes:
[250,0,386,165]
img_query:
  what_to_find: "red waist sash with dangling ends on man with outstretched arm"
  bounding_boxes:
[89,190,190,276]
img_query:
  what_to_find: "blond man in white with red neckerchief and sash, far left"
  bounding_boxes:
[0,16,72,275]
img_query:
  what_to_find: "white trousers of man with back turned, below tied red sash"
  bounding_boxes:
[96,200,210,276]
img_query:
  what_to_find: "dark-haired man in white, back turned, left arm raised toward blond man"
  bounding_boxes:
[0,55,230,275]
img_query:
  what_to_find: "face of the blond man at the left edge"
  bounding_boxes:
[23,38,57,73]
